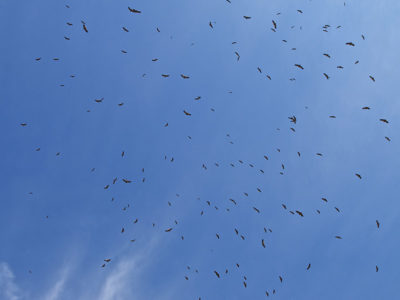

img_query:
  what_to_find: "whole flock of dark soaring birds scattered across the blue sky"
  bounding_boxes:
[12,0,391,300]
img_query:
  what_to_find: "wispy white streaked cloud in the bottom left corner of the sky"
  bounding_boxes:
[0,237,166,300]
